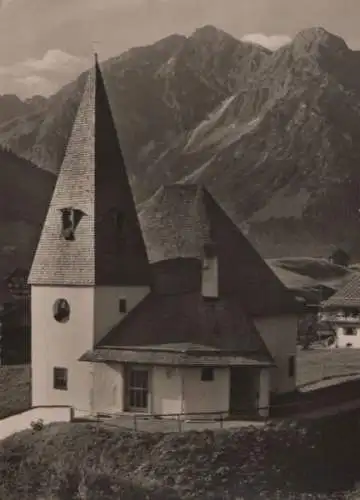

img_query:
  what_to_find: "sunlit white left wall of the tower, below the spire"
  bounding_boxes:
[31,286,94,411]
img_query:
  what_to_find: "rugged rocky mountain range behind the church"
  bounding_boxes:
[0,26,360,290]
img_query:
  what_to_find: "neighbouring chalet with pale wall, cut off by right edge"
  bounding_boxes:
[320,274,360,348]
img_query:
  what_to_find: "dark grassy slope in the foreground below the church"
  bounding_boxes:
[0,415,359,500]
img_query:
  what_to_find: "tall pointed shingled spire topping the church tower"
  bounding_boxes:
[29,54,150,286]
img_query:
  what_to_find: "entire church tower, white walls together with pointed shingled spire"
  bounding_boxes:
[29,53,150,412]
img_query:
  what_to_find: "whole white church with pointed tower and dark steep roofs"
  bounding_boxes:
[29,55,300,422]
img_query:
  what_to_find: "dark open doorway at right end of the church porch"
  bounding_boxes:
[230,366,260,417]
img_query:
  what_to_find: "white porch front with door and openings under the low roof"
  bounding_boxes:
[89,363,270,419]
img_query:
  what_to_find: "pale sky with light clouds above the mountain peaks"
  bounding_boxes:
[0,0,360,98]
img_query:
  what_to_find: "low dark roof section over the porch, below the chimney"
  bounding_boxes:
[81,292,273,364]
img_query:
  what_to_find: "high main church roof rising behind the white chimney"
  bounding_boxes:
[139,184,300,315]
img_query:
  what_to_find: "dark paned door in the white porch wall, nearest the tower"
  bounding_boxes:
[126,366,149,412]
